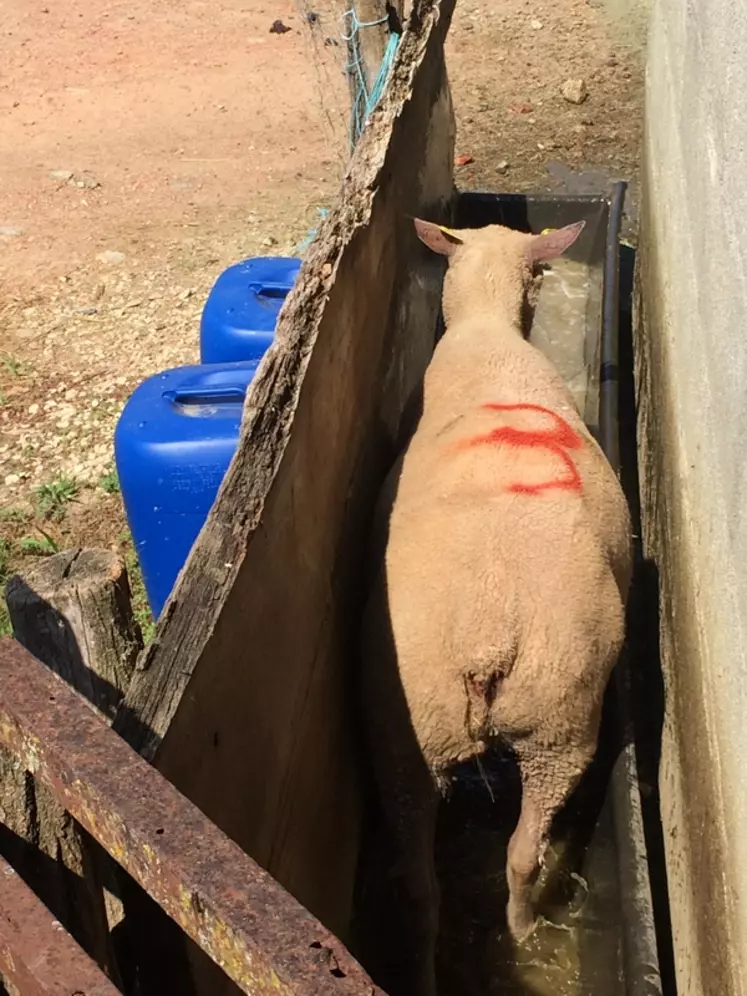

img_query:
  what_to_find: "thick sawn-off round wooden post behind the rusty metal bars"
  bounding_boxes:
[0,550,142,982]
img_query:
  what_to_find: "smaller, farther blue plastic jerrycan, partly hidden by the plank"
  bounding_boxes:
[200,256,301,363]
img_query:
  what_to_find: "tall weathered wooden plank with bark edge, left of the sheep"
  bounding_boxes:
[115,0,455,960]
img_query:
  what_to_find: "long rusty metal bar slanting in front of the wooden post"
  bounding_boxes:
[0,639,383,996]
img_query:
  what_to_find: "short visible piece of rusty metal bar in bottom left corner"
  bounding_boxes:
[0,858,119,996]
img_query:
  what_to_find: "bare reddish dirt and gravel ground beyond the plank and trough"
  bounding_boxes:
[0,0,645,625]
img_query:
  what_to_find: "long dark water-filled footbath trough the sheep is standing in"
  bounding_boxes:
[359,184,666,996]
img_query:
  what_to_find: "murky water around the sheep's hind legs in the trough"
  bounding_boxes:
[437,757,625,996]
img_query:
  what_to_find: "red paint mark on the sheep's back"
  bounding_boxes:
[459,404,582,495]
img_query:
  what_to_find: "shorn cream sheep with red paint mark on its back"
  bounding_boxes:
[362,219,632,996]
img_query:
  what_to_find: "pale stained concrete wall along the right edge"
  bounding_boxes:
[636,0,747,996]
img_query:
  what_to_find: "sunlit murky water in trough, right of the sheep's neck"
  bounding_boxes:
[529,257,591,414]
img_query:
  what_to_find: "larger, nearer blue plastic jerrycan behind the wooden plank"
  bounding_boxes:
[114,360,259,618]
